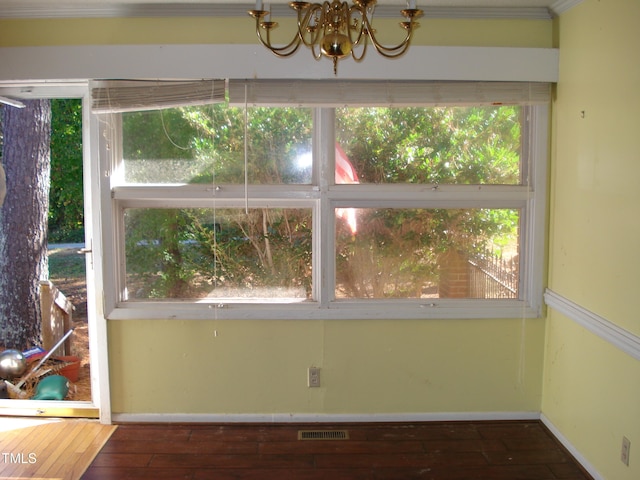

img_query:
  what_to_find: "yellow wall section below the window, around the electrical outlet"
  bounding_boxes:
[109,319,544,414]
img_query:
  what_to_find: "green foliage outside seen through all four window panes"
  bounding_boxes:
[117,105,522,298]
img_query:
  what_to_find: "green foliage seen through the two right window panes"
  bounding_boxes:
[336,106,521,298]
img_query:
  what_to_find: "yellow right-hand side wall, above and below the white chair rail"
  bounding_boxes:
[542,0,640,480]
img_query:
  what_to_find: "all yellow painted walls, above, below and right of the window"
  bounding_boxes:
[5,0,640,472]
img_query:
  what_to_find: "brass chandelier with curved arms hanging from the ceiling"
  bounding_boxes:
[249,0,422,75]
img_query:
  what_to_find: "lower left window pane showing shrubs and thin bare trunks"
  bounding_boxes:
[124,208,312,301]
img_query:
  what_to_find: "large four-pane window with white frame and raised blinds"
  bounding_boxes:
[94,81,548,318]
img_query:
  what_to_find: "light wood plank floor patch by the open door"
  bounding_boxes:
[0,417,117,480]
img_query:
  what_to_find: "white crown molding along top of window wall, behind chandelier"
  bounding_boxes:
[0,0,552,20]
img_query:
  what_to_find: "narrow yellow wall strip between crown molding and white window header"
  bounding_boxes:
[0,15,553,48]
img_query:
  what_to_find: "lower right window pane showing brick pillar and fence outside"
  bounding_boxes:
[335,208,520,299]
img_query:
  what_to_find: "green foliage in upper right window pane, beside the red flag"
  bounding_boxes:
[336,106,522,185]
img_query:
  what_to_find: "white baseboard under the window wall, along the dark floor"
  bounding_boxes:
[112,412,540,423]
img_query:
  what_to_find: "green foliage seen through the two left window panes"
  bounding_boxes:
[123,105,312,298]
